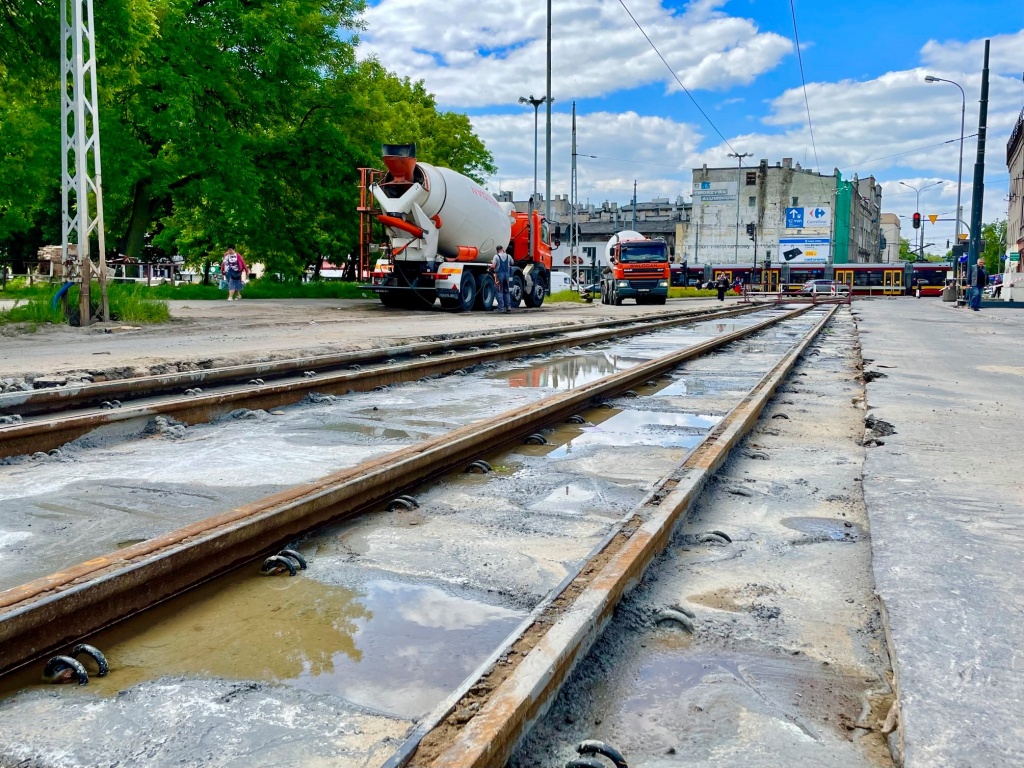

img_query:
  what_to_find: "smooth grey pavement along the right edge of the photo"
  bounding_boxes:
[854,300,1024,768]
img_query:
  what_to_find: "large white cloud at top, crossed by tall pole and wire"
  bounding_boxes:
[361,0,793,108]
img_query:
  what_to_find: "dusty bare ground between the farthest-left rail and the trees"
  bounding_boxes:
[0,298,738,386]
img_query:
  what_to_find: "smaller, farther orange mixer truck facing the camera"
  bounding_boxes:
[601,229,672,305]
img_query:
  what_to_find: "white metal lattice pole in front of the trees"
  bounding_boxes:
[60,0,111,326]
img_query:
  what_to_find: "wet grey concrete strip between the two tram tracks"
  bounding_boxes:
[0,313,790,589]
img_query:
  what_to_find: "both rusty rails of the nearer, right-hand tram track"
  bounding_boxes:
[0,307,835,766]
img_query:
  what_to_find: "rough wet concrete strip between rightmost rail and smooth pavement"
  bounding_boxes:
[510,310,893,768]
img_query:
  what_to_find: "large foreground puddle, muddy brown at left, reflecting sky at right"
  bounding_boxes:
[0,560,524,718]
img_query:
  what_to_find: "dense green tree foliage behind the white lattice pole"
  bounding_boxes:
[0,0,495,273]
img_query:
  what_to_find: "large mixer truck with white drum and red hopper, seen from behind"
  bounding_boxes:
[365,144,558,311]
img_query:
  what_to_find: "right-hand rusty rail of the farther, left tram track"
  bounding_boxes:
[0,305,765,459]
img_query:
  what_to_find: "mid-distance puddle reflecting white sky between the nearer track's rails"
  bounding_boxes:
[547,411,719,459]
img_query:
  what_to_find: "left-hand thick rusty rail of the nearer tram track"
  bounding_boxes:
[0,307,810,674]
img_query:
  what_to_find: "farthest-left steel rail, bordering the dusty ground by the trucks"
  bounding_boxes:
[0,302,774,416]
